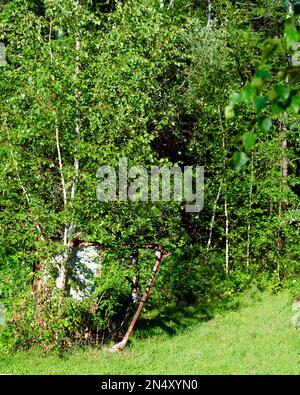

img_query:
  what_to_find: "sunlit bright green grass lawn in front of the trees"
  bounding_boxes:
[0,291,300,374]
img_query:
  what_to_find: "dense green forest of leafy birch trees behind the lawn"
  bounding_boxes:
[0,0,300,349]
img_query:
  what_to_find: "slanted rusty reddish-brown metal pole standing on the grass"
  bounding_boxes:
[110,249,164,353]
